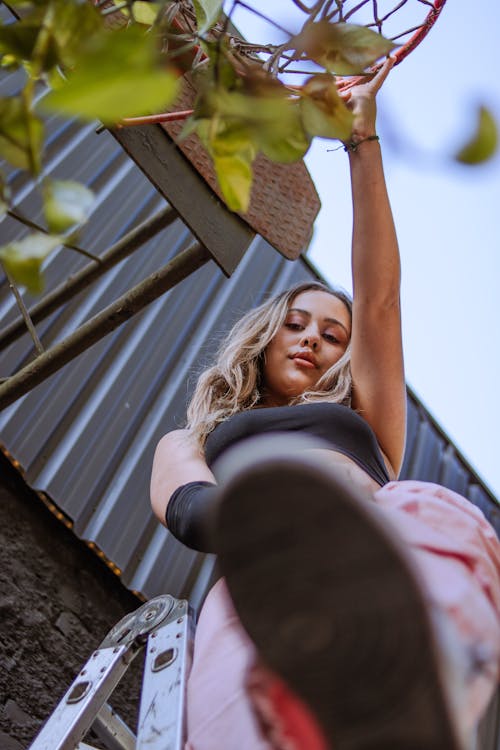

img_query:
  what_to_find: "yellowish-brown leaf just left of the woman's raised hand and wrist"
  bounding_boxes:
[300,73,353,141]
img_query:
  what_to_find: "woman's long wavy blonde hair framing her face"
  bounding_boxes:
[187,282,352,447]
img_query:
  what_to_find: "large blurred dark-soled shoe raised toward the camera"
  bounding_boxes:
[216,437,465,750]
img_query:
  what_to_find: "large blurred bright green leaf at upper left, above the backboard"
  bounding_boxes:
[40,26,178,125]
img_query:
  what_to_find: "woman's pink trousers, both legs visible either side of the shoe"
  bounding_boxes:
[186,481,500,750]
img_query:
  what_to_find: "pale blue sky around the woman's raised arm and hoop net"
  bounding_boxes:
[227,0,500,506]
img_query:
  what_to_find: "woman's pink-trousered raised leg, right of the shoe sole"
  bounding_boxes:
[375,481,500,727]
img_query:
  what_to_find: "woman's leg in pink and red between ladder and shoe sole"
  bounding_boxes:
[186,579,327,750]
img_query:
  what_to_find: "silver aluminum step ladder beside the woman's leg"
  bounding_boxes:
[29,595,194,750]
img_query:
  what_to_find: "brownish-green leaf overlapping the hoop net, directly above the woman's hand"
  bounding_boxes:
[290,21,397,75]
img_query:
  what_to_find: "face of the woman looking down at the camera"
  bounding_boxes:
[262,290,351,406]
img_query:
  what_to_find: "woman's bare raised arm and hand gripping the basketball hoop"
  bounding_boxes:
[344,59,406,475]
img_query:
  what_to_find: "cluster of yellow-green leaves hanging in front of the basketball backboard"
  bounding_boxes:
[185,48,352,213]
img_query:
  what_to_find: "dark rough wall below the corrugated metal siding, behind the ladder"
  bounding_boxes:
[0,456,141,750]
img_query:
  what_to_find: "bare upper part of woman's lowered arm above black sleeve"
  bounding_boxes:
[151,430,215,526]
